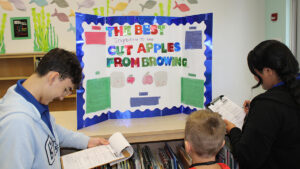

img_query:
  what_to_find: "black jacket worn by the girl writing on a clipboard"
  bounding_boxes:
[229,85,300,169]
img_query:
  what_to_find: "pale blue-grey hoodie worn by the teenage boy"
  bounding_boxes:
[0,85,89,169]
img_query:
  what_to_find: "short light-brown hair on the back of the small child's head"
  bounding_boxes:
[184,110,226,157]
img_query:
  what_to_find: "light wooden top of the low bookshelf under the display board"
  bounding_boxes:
[50,111,187,143]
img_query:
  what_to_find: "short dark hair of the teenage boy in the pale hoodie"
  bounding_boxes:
[35,48,82,88]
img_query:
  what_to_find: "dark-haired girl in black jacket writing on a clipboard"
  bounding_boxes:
[224,40,300,169]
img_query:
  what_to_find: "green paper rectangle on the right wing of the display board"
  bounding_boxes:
[181,78,204,108]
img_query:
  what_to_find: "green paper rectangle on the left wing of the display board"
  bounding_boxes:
[86,77,111,113]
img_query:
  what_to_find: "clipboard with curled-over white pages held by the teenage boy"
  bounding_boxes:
[61,132,134,169]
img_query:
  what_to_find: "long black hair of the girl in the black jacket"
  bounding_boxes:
[248,40,300,104]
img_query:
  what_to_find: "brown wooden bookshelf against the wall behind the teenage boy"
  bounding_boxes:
[0,53,76,111]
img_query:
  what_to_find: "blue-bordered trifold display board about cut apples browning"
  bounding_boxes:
[76,13,213,129]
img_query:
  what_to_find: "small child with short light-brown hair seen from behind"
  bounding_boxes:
[184,110,229,169]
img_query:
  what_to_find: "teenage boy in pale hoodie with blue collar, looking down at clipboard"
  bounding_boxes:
[0,48,108,169]
